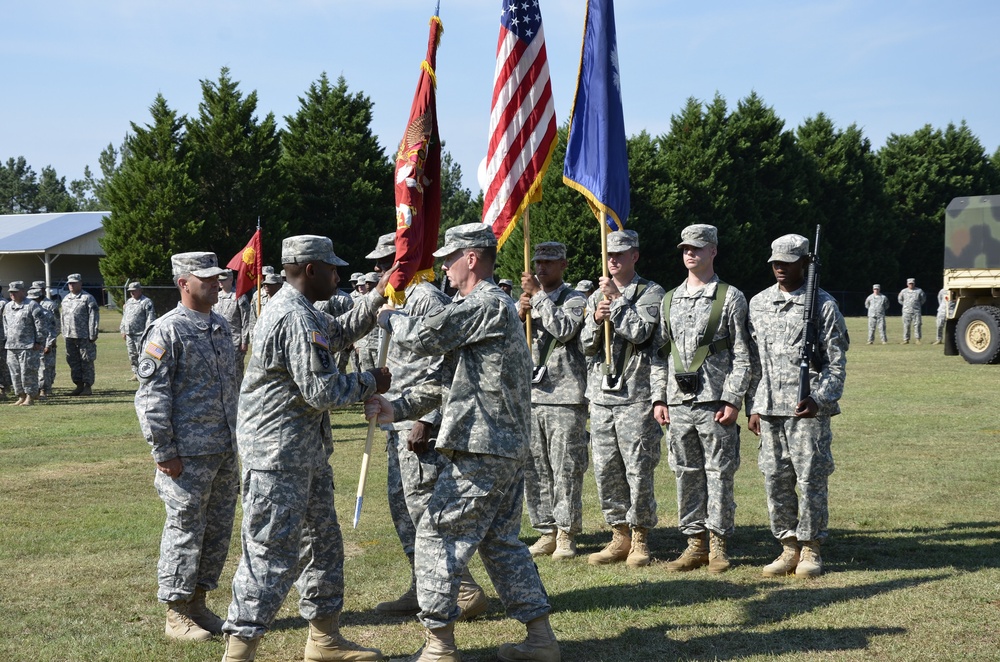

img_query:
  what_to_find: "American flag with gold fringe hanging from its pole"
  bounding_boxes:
[483,0,556,246]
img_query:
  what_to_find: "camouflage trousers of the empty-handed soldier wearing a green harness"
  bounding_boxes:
[667,402,740,536]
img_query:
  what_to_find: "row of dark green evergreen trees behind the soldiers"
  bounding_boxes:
[0,68,1000,308]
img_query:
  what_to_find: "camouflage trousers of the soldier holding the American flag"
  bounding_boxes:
[524,405,589,534]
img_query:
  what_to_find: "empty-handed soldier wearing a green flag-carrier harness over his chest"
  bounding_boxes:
[652,224,750,574]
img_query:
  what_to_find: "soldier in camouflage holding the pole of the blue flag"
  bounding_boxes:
[580,230,664,567]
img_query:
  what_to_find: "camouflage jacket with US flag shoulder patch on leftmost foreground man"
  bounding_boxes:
[135,303,239,462]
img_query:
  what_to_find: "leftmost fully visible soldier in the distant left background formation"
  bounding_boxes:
[0,280,48,405]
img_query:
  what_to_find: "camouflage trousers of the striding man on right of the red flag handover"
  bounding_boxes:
[415,451,552,629]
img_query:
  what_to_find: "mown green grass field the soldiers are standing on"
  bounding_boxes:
[0,313,1000,662]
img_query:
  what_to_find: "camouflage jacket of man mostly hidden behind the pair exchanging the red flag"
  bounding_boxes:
[383,283,451,430]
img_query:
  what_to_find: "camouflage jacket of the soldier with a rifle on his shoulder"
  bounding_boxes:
[746,284,851,416]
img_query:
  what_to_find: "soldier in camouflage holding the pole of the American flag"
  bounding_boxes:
[518,241,588,559]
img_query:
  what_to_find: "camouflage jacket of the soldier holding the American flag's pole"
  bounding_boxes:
[531,283,587,405]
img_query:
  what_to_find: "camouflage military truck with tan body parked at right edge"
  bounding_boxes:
[944,195,1000,363]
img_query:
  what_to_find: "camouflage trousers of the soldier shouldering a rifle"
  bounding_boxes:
[757,416,834,540]
